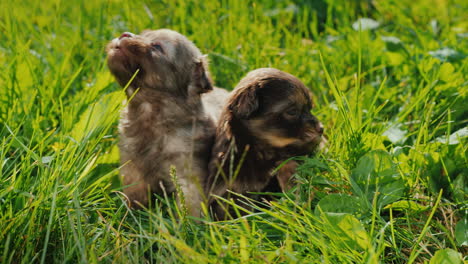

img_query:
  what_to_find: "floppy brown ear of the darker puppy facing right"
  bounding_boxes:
[228,85,258,119]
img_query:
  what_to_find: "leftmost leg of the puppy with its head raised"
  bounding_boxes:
[121,161,149,208]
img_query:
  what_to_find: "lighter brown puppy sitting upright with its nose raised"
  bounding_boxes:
[106,29,227,216]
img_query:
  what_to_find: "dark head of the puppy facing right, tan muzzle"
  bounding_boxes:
[227,68,323,155]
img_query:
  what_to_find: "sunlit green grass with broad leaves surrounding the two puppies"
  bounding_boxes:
[0,0,468,263]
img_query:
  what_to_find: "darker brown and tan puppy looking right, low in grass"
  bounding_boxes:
[205,68,323,219]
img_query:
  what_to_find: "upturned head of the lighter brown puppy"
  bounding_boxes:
[106,29,212,95]
